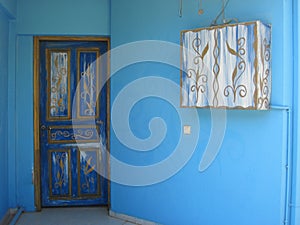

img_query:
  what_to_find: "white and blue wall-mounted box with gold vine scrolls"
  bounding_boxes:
[181,21,271,110]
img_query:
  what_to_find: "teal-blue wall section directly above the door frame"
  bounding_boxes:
[17,0,110,35]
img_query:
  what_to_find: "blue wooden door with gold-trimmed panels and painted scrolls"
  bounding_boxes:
[40,40,108,207]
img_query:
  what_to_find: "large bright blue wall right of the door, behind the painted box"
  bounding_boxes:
[111,0,292,225]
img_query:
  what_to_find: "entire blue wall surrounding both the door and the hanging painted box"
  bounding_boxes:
[5,0,293,225]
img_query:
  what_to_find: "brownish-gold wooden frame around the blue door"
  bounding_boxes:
[32,36,111,211]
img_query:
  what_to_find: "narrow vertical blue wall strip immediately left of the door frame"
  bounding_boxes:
[15,36,34,210]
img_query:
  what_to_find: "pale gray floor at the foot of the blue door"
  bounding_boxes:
[17,207,133,225]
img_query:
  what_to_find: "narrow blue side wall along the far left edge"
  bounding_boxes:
[0,8,9,221]
